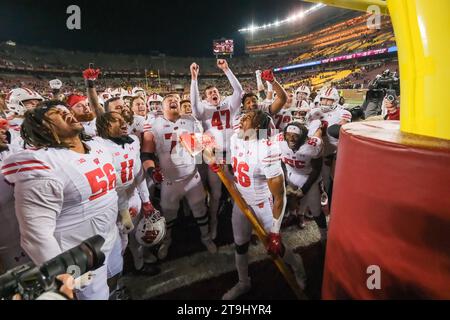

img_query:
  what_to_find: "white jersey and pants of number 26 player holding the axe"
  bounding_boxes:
[231,134,283,245]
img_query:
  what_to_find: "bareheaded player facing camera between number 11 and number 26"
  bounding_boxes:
[141,94,217,259]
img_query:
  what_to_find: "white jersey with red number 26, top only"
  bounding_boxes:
[231,134,283,205]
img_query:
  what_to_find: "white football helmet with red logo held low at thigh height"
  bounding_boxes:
[135,210,166,247]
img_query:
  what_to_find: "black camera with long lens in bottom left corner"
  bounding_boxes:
[0,235,105,300]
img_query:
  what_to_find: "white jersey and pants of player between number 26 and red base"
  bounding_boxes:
[280,134,323,216]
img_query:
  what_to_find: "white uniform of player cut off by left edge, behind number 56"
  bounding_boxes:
[0,146,30,270]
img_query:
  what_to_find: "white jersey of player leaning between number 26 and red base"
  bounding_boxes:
[280,134,323,187]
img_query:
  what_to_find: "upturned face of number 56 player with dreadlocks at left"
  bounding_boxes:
[45,106,83,138]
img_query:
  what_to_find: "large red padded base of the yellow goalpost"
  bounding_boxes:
[322,121,450,299]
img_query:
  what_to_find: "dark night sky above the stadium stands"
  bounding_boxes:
[0,0,311,57]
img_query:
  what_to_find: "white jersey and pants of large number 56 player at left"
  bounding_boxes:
[2,141,118,299]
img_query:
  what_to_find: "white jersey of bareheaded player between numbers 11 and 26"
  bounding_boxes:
[148,115,202,182]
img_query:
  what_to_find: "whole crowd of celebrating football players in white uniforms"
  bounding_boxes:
[0,59,352,300]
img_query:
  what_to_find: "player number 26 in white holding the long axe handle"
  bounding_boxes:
[222,110,306,300]
